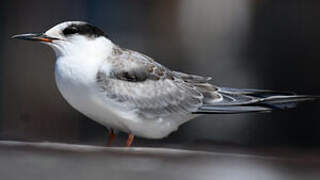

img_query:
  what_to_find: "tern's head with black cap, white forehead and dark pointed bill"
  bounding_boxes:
[12,21,110,56]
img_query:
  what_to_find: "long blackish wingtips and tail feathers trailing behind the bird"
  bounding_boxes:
[193,87,320,114]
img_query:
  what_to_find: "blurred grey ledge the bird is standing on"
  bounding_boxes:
[0,141,320,180]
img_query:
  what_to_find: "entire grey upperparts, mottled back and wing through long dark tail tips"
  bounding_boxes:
[97,46,304,116]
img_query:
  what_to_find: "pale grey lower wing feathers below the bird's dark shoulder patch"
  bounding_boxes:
[99,79,203,119]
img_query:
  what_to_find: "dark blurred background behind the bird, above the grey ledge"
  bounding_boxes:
[0,0,320,147]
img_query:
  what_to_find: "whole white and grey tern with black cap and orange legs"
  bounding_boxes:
[12,21,319,147]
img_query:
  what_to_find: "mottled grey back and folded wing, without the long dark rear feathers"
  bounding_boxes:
[97,51,203,119]
